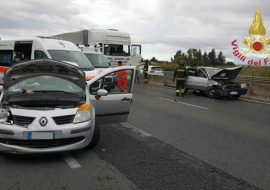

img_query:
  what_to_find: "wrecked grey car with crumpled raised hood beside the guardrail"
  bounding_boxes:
[185,67,247,99]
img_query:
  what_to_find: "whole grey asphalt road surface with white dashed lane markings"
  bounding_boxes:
[0,85,270,190]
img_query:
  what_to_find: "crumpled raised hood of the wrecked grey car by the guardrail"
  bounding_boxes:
[211,67,242,81]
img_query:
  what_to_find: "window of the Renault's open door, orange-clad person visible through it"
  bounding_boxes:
[90,70,133,95]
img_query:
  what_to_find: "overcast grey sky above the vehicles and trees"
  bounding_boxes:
[0,0,270,62]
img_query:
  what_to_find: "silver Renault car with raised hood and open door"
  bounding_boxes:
[0,60,135,153]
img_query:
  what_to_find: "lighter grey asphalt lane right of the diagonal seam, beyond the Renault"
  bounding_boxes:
[128,85,270,189]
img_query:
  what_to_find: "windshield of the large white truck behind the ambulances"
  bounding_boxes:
[104,44,130,56]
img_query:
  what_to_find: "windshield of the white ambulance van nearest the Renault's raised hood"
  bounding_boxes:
[48,50,94,70]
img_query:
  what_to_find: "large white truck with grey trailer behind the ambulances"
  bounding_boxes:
[50,29,142,66]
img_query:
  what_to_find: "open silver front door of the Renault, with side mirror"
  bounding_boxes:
[88,66,135,123]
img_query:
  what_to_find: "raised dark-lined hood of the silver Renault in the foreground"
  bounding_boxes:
[4,59,85,90]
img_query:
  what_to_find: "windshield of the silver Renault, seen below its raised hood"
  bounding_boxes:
[8,75,84,94]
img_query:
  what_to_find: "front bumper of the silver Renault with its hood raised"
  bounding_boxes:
[0,120,95,154]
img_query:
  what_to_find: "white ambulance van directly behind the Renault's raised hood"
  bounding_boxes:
[0,38,97,80]
